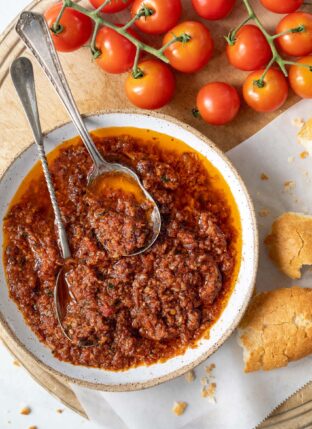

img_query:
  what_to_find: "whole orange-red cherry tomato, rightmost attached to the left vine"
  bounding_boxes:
[163,21,213,73]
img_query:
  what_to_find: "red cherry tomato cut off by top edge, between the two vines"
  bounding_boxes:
[192,0,236,20]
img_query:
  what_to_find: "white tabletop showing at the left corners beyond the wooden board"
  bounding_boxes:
[0,0,98,429]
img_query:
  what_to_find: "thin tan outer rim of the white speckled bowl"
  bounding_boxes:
[0,109,259,392]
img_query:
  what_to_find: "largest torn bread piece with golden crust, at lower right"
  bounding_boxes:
[238,286,312,372]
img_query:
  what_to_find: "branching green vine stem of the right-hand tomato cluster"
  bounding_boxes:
[225,0,312,88]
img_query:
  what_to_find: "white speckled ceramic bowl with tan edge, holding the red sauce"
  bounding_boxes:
[0,112,258,391]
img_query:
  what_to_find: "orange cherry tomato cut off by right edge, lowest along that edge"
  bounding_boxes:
[289,55,312,98]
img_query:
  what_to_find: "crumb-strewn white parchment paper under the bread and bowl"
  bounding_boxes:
[72,100,312,429]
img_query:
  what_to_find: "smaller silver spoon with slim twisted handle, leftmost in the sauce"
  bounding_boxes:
[10,57,75,340]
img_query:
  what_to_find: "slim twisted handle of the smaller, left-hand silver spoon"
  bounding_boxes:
[10,57,71,259]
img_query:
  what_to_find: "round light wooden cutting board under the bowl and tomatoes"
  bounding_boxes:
[0,0,312,429]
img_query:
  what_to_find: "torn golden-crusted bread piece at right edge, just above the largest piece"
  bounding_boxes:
[264,212,312,279]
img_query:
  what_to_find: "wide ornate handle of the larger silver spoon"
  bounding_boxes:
[16,12,106,167]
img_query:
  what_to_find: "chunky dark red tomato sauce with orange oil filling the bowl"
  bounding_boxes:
[4,126,240,370]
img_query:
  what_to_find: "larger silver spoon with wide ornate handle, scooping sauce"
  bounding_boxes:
[16,12,161,256]
